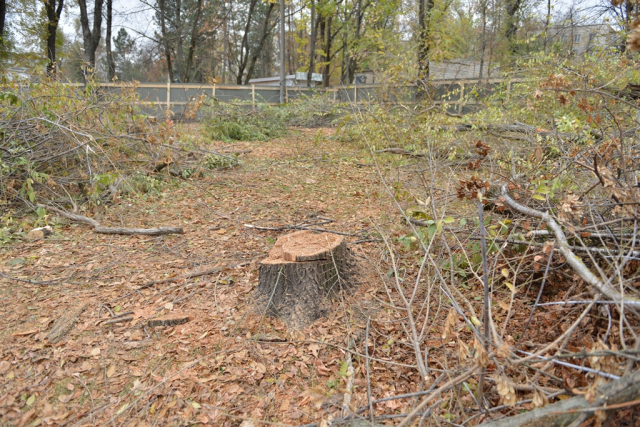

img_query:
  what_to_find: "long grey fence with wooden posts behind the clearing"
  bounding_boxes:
[75,79,524,115]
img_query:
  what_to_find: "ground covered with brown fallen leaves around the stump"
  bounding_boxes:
[0,130,415,427]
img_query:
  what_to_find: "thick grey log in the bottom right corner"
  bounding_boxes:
[480,371,640,427]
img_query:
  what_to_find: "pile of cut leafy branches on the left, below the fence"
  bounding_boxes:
[0,78,228,240]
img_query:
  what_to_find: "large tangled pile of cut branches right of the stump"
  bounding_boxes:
[342,52,640,426]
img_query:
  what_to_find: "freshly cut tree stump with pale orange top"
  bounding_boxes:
[256,230,355,329]
